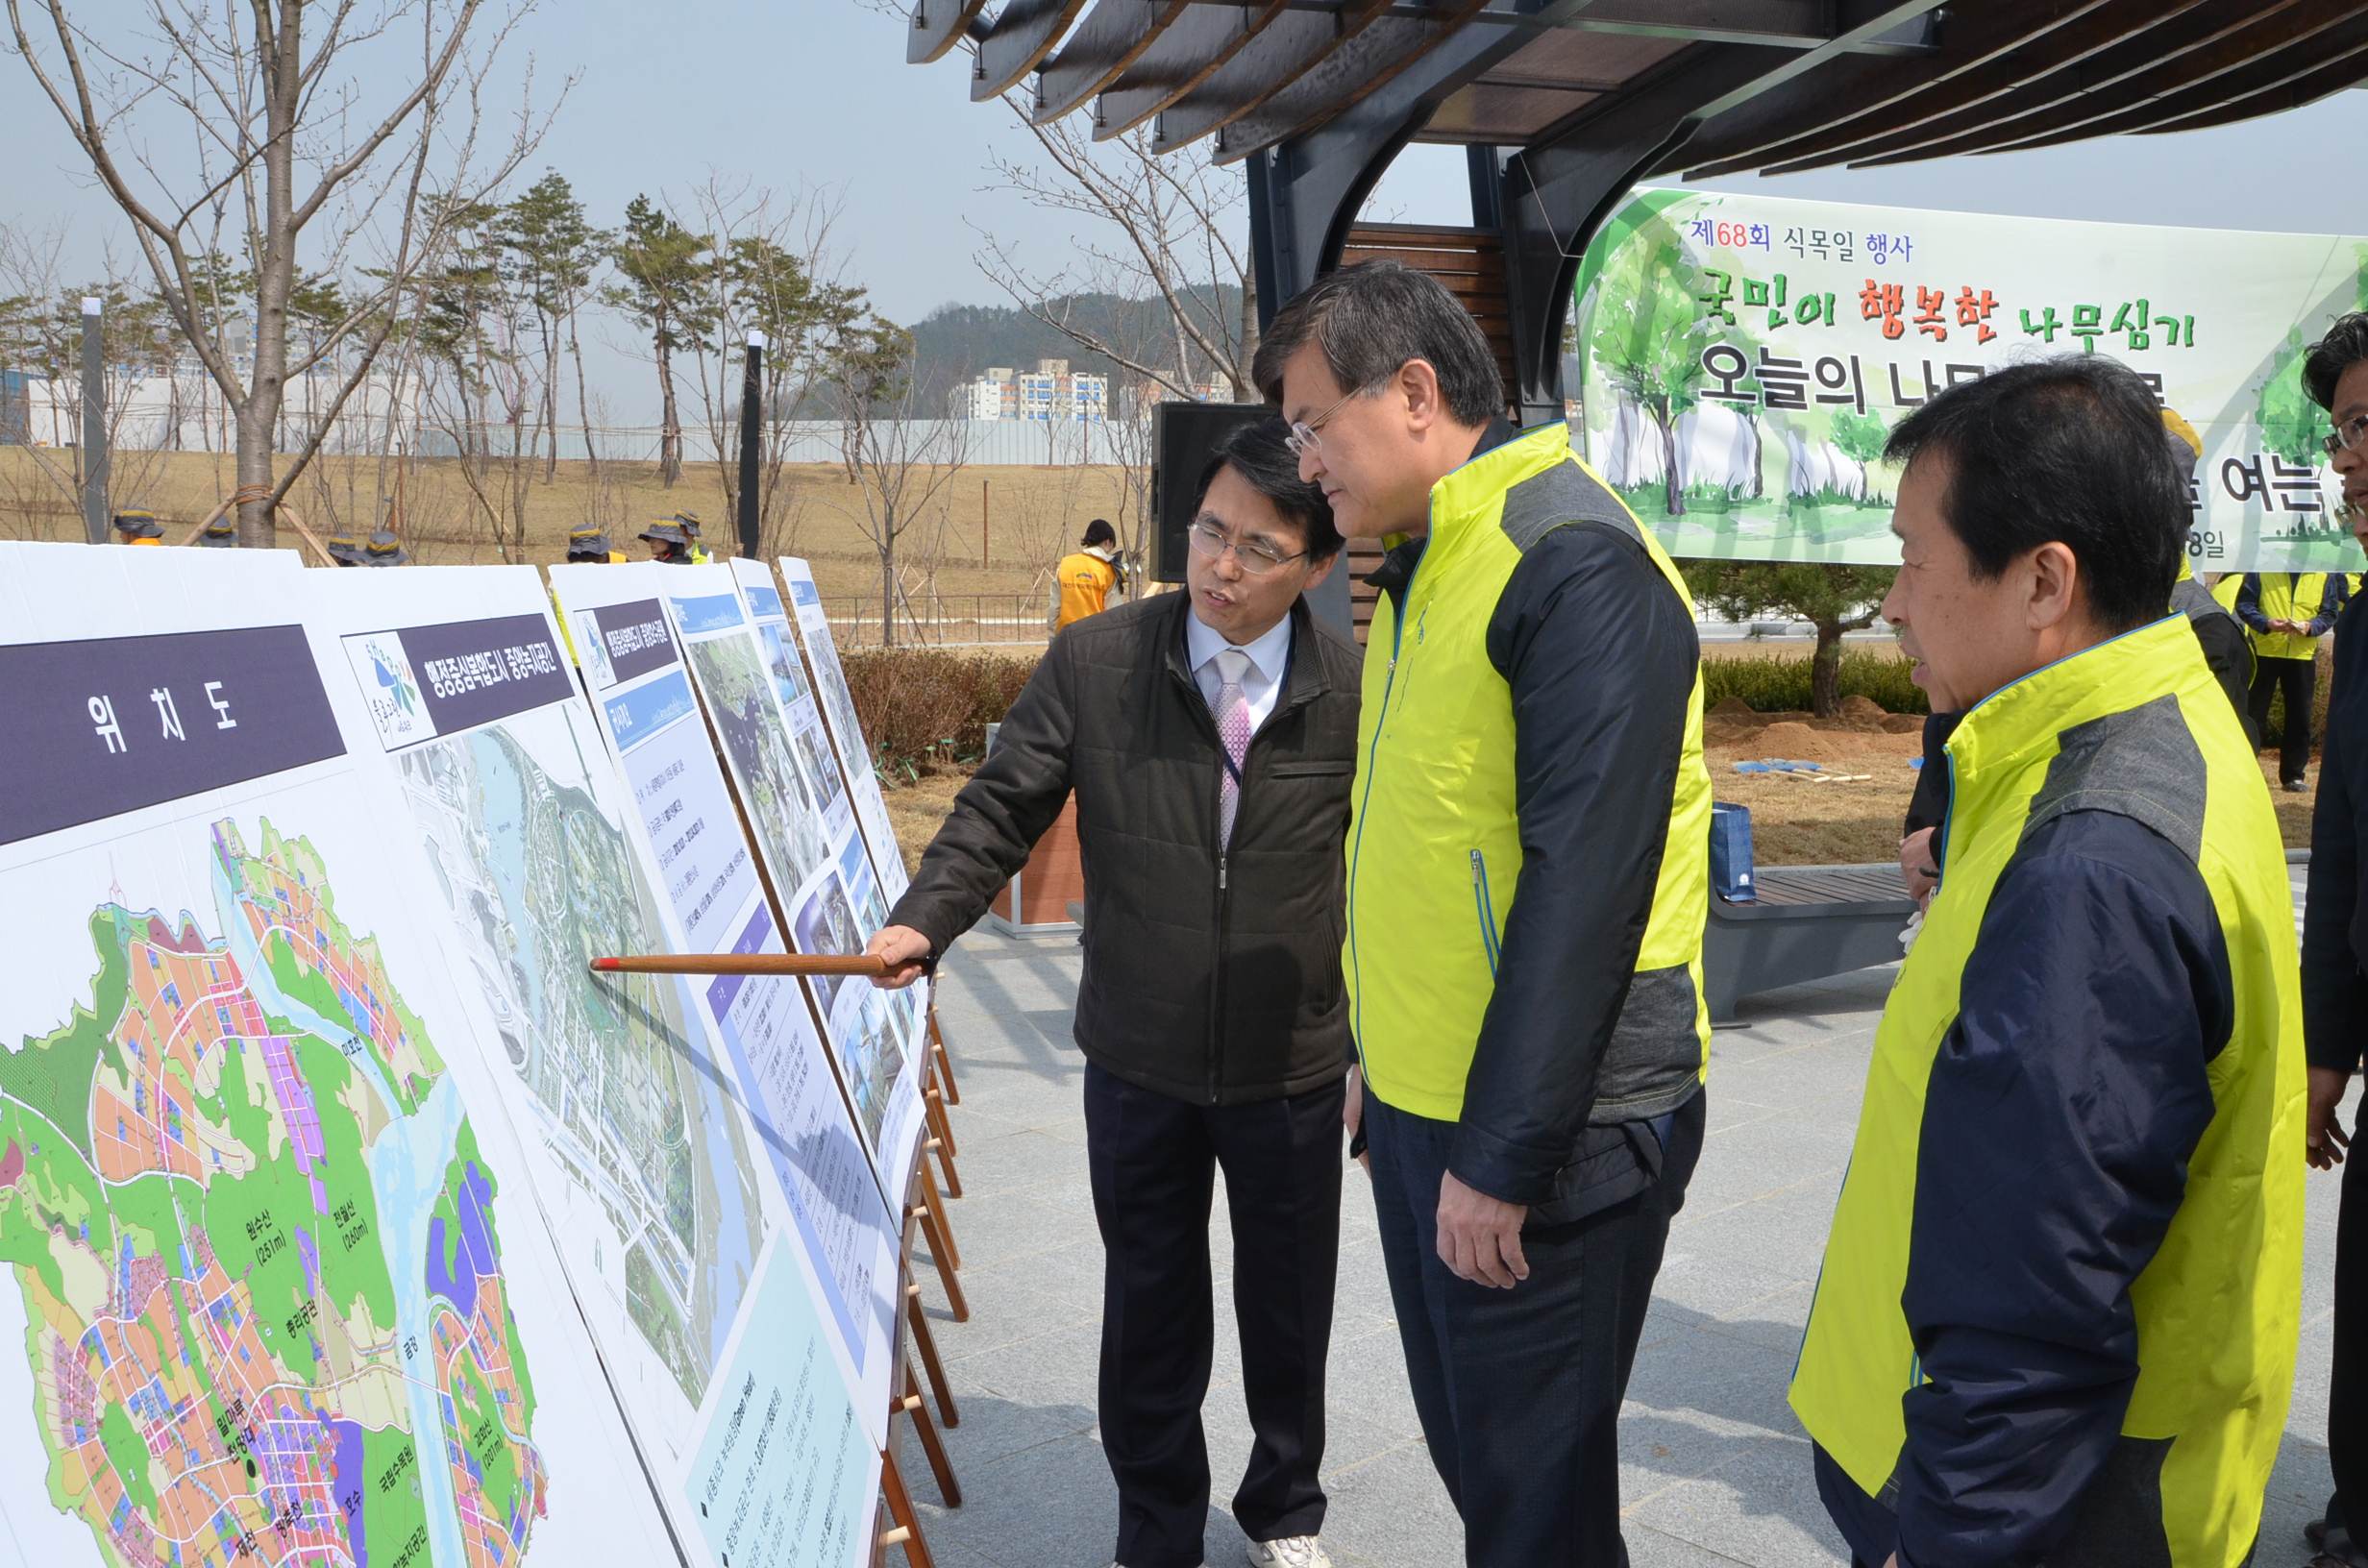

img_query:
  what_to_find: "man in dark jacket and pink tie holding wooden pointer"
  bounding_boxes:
[869,419,1362,1568]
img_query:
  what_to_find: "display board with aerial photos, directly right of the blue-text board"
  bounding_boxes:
[660,566,925,1215]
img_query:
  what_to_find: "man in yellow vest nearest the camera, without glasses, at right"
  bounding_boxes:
[1792,355,2304,1568]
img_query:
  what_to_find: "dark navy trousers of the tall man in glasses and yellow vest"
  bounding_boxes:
[1364,1091,1703,1568]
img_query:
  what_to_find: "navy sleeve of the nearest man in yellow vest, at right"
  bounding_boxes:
[1897,813,2233,1568]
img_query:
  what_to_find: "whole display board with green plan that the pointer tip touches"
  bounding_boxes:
[312,566,893,1568]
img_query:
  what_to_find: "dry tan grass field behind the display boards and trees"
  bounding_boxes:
[0,448,1146,597]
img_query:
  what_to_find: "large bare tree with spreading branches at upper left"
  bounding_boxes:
[7,0,540,545]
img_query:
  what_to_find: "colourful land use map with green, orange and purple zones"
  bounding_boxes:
[0,820,550,1568]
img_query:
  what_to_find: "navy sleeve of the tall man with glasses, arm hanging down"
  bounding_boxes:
[1449,524,1708,1203]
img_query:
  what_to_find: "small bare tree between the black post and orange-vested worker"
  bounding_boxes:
[833,315,971,647]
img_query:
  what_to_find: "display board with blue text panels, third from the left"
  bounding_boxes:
[552,564,909,1437]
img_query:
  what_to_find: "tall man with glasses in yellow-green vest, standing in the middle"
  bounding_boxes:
[1252,260,1710,1568]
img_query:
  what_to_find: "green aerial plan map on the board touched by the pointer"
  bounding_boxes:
[400,706,762,1407]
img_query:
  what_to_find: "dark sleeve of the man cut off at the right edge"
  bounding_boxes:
[2302,600,2368,1073]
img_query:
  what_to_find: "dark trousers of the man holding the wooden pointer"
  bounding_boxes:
[1085,1064,1343,1568]
